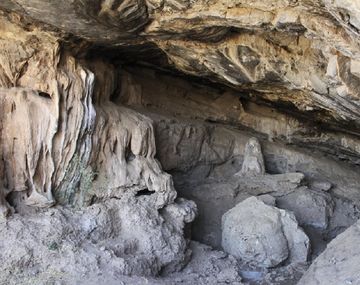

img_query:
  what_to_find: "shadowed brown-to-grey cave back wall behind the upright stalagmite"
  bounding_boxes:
[120,67,360,201]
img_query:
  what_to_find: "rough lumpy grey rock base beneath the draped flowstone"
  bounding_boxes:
[0,195,195,284]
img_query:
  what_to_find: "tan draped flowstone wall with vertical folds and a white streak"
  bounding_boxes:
[0,13,176,214]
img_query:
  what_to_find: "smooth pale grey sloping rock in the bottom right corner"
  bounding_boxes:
[298,219,360,285]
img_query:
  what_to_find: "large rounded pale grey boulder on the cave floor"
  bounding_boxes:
[222,197,310,267]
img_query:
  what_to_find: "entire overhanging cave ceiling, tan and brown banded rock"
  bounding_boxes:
[0,0,360,137]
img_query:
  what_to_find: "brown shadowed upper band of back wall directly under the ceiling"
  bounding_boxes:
[114,66,360,165]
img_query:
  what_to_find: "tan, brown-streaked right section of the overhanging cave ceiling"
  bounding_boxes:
[145,1,359,130]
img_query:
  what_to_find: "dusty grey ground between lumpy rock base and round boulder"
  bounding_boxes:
[33,242,243,285]
